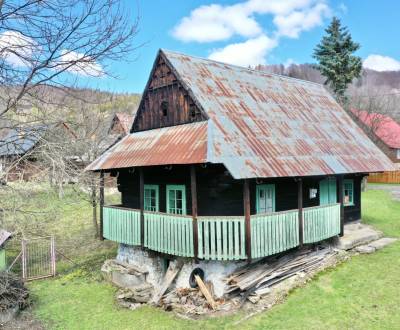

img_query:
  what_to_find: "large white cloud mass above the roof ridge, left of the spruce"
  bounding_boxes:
[172,0,330,65]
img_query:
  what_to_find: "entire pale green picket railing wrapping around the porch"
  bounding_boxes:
[103,203,340,260]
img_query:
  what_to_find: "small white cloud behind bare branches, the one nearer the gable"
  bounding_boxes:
[58,49,104,77]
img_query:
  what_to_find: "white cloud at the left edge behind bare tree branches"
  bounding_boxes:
[0,31,39,67]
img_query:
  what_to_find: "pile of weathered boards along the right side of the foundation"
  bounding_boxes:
[226,248,337,303]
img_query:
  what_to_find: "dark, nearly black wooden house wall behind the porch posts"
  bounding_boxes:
[118,165,362,221]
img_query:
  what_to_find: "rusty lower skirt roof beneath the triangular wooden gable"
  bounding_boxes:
[86,122,207,171]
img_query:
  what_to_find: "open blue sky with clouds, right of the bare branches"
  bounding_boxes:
[83,0,400,93]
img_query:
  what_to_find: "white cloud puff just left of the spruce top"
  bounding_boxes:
[273,3,330,38]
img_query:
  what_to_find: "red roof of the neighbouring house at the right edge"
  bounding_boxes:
[352,109,400,149]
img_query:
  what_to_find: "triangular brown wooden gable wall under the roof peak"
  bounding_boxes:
[133,55,207,132]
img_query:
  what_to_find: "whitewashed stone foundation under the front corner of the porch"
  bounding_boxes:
[117,244,246,297]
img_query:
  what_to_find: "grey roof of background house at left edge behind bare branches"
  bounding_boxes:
[0,125,47,156]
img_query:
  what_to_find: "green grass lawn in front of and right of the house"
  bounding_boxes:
[30,187,400,329]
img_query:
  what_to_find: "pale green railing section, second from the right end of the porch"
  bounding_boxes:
[251,210,299,258]
